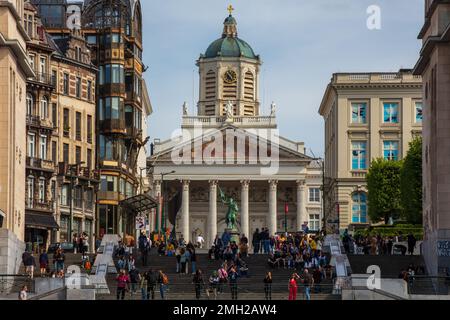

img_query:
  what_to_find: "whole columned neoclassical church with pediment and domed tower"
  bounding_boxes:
[148,12,322,246]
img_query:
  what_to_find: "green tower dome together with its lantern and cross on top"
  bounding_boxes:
[204,14,258,59]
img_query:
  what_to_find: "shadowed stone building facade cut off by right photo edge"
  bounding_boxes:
[414,0,450,275]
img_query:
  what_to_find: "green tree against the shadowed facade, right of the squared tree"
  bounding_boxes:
[400,137,422,224]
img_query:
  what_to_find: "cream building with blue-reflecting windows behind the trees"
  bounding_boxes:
[319,70,422,231]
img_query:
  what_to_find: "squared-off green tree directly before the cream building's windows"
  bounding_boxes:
[367,158,402,224]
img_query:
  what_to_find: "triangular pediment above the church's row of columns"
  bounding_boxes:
[150,124,313,164]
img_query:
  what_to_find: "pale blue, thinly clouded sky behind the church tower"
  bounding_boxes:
[141,0,424,157]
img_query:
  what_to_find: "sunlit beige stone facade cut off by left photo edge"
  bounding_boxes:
[0,0,35,274]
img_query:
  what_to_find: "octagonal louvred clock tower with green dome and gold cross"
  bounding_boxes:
[197,6,261,117]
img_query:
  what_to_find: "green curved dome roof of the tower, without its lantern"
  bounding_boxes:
[205,37,258,59]
